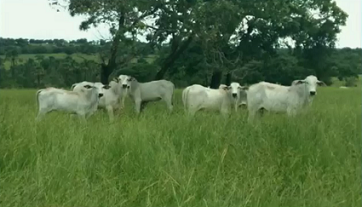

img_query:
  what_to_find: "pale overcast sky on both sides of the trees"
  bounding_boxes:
[0,0,362,48]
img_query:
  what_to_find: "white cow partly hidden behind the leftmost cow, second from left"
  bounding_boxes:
[73,81,124,121]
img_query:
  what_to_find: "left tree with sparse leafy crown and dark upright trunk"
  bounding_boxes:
[49,0,166,84]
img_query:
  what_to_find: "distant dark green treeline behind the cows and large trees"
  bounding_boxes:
[0,39,362,88]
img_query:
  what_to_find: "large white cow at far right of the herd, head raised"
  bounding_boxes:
[247,76,323,121]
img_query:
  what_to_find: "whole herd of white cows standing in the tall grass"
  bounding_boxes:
[36,75,324,121]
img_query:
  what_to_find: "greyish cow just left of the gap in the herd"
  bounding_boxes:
[126,77,175,114]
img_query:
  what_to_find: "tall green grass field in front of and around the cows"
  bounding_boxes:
[0,88,362,207]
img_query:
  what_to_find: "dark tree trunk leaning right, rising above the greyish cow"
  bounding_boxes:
[155,34,193,80]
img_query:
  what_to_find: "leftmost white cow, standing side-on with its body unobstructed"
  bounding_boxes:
[36,84,102,120]
